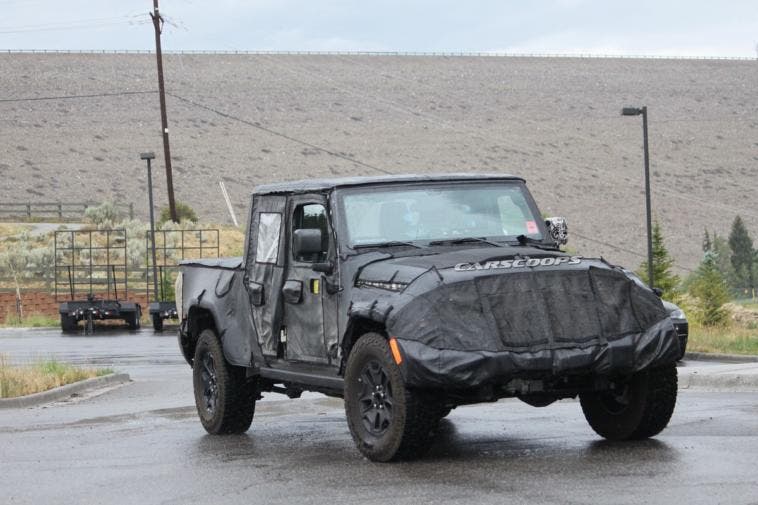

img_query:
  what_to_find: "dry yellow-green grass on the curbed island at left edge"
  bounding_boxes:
[0,355,113,398]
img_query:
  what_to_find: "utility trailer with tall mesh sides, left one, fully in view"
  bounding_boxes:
[54,229,142,334]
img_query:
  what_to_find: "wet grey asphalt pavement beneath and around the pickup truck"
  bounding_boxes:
[0,330,758,505]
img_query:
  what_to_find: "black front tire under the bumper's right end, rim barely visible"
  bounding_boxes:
[579,364,677,440]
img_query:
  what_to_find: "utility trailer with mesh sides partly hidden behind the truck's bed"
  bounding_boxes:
[145,229,219,331]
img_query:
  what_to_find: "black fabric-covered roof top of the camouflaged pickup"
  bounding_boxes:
[253,173,524,195]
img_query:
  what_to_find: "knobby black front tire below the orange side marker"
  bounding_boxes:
[344,333,440,462]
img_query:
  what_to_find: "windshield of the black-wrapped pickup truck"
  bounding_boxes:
[341,182,542,247]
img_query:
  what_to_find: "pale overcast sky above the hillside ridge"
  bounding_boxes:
[0,0,758,57]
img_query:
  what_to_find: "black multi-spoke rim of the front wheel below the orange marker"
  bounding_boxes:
[358,360,395,436]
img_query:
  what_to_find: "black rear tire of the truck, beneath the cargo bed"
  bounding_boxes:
[192,329,258,435]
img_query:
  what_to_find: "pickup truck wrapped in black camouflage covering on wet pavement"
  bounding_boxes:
[177,174,681,461]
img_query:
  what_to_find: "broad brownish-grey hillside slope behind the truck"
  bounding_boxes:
[0,53,758,268]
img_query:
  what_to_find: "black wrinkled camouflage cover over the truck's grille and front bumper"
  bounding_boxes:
[387,260,679,387]
